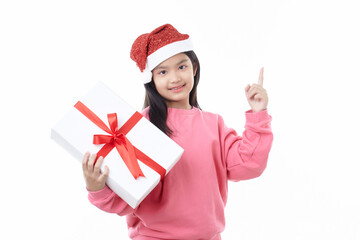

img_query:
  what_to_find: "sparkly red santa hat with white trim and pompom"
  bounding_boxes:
[130,24,193,84]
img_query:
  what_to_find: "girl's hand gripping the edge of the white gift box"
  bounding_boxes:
[82,152,109,191]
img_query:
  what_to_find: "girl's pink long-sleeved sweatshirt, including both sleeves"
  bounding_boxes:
[89,108,273,240]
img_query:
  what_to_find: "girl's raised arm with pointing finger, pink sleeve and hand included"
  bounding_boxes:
[224,68,273,181]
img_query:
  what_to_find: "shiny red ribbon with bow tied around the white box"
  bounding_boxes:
[74,101,166,180]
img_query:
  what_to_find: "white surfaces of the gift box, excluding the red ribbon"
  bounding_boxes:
[51,82,184,208]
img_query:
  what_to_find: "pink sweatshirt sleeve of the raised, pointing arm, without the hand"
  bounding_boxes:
[220,110,273,181]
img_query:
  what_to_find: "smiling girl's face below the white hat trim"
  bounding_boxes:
[153,53,196,109]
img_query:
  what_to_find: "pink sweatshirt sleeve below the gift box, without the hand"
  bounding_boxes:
[88,185,135,216]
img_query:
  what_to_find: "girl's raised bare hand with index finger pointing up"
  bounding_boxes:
[245,67,269,112]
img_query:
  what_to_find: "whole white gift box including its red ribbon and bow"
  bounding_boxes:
[51,83,183,208]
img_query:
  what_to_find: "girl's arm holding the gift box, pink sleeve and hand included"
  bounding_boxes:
[82,153,135,216]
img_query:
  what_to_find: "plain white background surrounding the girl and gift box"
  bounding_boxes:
[0,0,360,240]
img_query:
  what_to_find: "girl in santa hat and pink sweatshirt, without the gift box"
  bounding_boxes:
[83,24,273,240]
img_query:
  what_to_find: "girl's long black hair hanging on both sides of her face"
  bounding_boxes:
[144,51,201,136]
